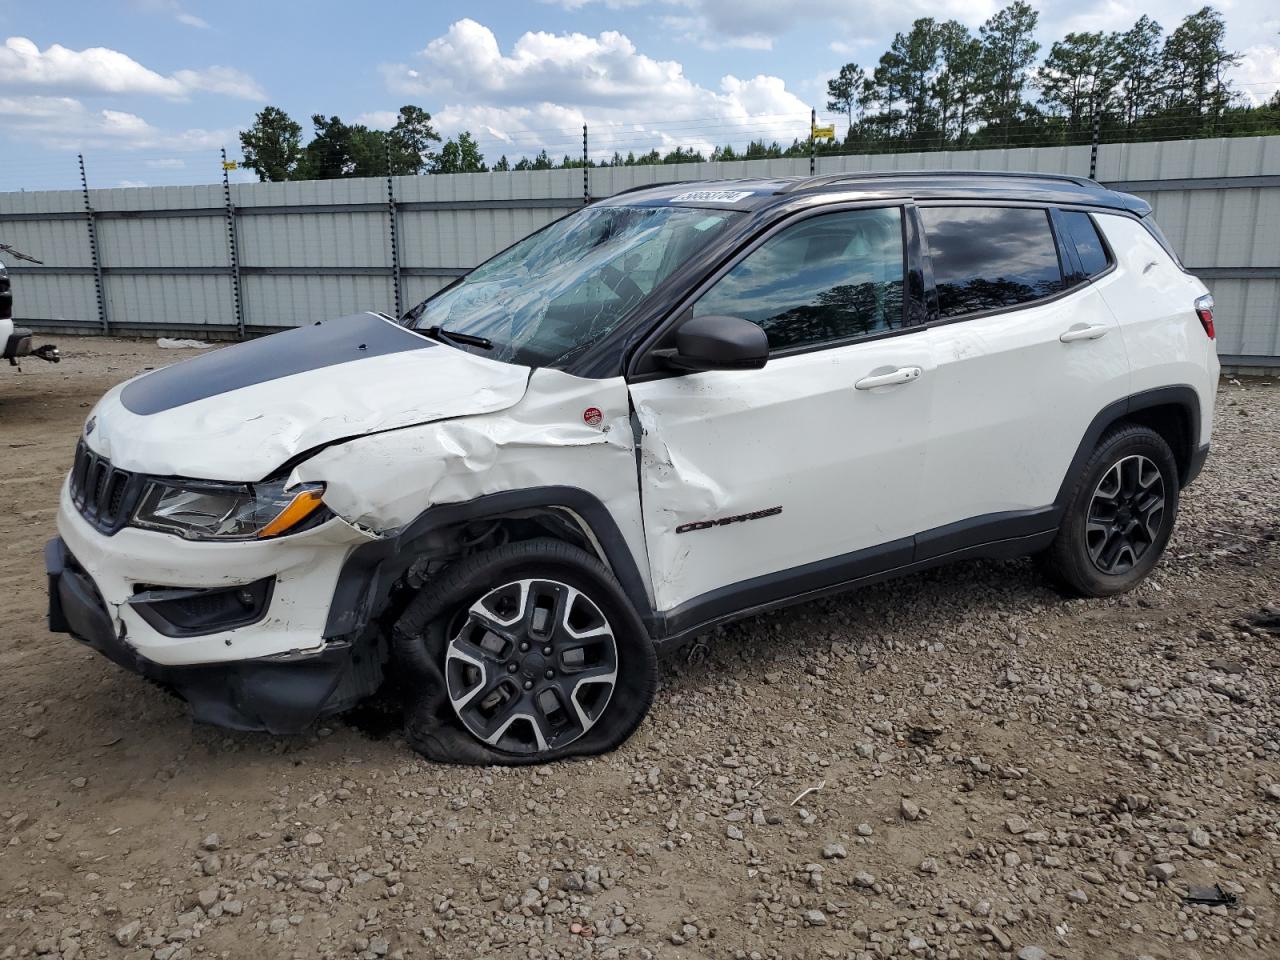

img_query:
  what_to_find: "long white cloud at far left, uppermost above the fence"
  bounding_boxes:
[0,37,266,100]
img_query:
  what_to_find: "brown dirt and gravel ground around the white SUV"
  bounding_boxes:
[0,338,1280,960]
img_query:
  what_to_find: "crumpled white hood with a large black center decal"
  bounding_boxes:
[84,314,530,480]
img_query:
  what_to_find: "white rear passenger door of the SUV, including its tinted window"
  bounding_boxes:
[916,202,1129,547]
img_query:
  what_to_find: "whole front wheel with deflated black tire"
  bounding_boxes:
[394,540,657,764]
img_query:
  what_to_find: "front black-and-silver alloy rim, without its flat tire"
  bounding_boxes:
[444,580,618,754]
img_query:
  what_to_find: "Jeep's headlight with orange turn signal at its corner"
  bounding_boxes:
[133,480,324,540]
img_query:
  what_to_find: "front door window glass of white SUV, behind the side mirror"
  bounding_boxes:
[694,207,902,349]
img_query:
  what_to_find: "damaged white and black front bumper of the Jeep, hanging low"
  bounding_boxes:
[45,484,384,733]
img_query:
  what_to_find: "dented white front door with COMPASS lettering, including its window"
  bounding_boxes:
[630,206,933,632]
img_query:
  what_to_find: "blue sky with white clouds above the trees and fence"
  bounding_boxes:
[0,0,1280,191]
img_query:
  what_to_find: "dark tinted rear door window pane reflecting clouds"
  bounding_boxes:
[920,206,1062,316]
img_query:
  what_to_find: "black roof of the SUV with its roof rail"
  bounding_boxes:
[603,170,1151,216]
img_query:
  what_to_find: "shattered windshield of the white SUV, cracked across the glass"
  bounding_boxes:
[412,206,742,366]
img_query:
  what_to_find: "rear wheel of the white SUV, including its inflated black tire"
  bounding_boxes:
[1037,424,1179,596]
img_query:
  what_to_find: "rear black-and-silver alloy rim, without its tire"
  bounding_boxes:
[1084,454,1165,576]
